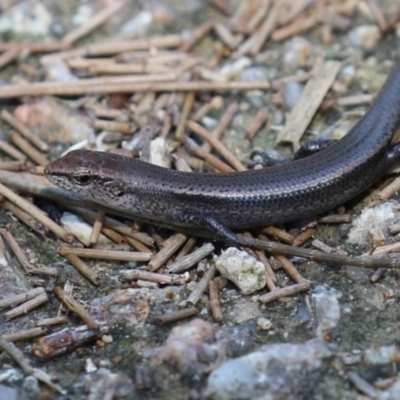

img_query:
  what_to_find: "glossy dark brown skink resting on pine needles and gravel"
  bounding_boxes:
[45,64,400,245]
